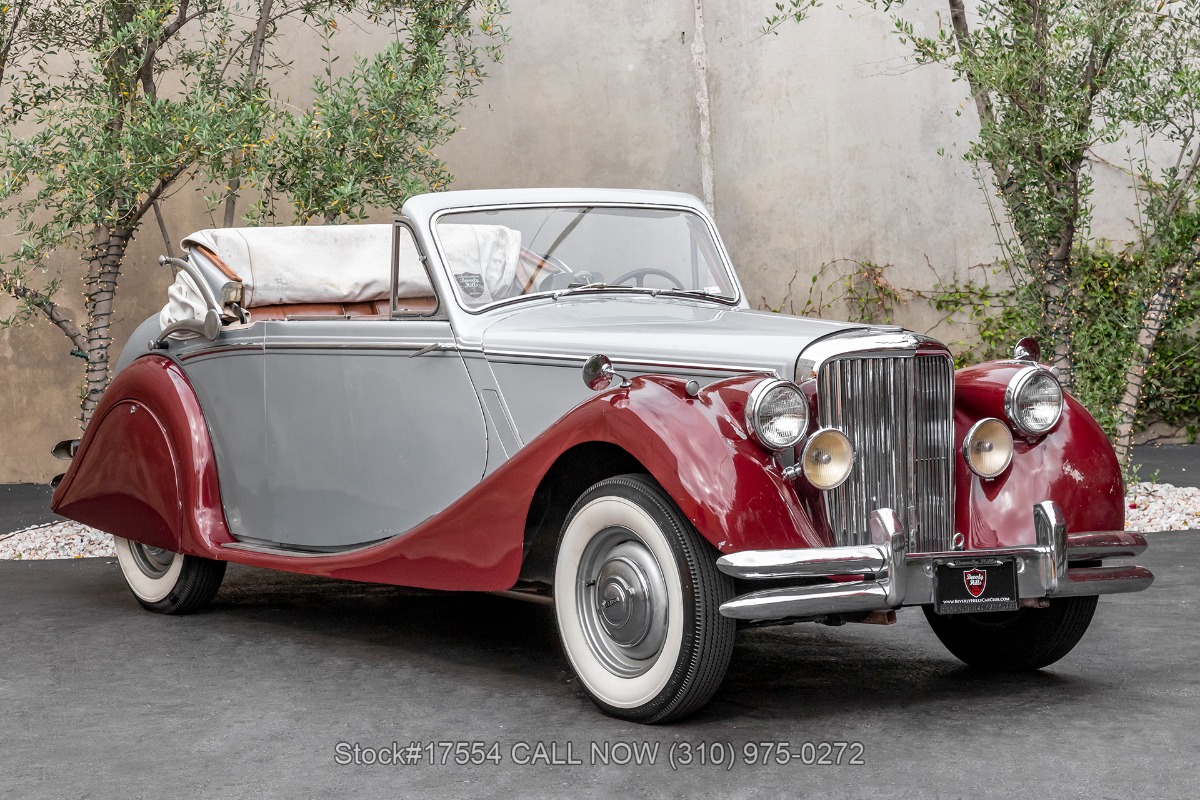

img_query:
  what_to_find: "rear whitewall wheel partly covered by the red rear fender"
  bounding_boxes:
[113,536,226,614]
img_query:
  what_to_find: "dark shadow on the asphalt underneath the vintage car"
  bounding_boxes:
[177,566,1103,728]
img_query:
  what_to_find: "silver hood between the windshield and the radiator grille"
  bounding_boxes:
[482,294,868,378]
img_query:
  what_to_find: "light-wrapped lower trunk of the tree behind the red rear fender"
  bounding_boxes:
[79,228,133,428]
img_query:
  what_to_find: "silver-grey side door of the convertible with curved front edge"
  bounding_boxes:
[265,319,487,549]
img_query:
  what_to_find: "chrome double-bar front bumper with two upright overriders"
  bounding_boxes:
[716,500,1154,621]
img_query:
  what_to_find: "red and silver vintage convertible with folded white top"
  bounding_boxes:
[53,190,1153,722]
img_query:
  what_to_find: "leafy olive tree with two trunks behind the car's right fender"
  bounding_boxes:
[768,0,1200,461]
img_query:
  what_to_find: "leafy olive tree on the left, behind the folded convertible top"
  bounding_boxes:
[0,0,506,425]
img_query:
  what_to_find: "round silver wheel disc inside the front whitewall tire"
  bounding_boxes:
[576,528,667,678]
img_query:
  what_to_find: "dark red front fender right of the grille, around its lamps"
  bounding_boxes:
[954,362,1124,549]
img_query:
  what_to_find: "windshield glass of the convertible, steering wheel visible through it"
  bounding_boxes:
[437,206,737,308]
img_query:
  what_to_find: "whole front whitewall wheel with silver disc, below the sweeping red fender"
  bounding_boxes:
[554,475,734,723]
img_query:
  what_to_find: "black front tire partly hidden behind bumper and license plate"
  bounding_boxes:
[924,595,1099,672]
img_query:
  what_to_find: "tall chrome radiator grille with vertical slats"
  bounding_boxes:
[817,355,954,553]
